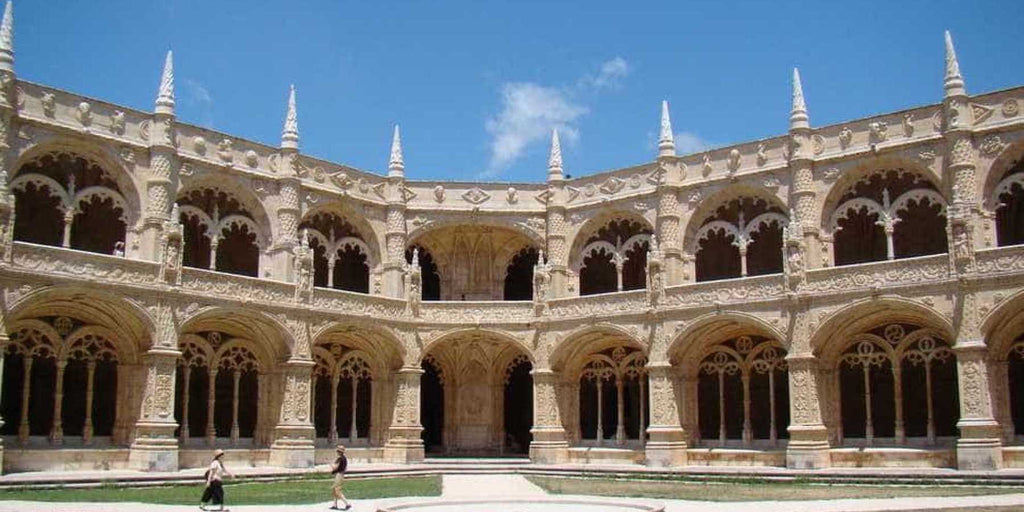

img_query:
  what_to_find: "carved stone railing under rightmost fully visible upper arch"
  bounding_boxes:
[798,253,950,293]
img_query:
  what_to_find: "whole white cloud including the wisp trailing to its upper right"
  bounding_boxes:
[477,57,630,178]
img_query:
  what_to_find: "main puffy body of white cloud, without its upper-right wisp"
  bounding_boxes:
[485,82,587,176]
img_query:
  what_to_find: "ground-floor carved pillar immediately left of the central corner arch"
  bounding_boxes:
[384,367,424,463]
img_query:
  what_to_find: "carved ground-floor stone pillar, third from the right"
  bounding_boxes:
[644,362,686,467]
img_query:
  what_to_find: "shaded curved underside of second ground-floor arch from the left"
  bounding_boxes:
[179,307,295,369]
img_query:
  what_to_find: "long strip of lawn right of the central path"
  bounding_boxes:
[526,476,1024,502]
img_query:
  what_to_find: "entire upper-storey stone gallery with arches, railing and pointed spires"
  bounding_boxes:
[0,0,1024,322]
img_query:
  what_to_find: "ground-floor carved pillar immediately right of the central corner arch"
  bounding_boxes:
[529,369,569,464]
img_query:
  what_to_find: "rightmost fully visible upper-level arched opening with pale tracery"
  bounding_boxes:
[828,169,947,265]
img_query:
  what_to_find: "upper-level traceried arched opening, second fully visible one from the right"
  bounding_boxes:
[694,197,788,282]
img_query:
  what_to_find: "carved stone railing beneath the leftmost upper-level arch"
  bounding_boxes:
[12,242,160,285]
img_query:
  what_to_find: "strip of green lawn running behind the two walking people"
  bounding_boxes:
[0,475,441,505]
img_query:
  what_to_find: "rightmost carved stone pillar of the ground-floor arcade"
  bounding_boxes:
[953,340,1002,470]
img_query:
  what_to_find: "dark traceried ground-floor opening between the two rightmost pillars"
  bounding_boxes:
[837,323,959,444]
